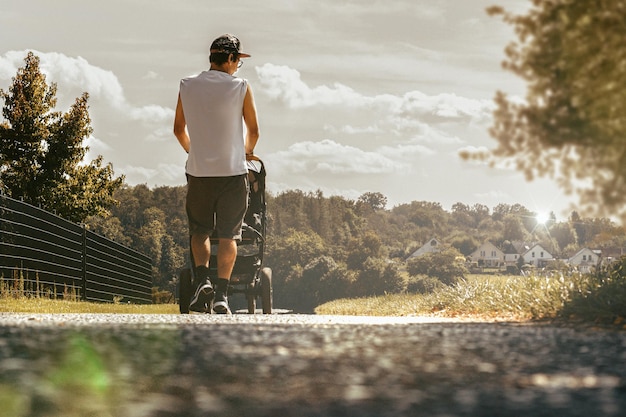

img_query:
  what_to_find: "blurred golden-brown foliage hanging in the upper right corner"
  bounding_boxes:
[487,0,626,221]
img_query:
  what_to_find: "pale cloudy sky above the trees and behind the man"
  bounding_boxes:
[0,0,570,218]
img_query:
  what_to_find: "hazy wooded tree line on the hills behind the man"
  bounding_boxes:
[86,185,626,311]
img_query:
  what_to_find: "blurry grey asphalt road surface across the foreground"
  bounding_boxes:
[0,314,626,417]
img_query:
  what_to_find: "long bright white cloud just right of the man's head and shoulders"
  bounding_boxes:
[256,64,494,145]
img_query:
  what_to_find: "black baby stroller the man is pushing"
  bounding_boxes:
[178,159,272,314]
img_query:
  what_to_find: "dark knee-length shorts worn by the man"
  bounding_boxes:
[186,174,248,240]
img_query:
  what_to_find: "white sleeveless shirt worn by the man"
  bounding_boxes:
[179,71,248,177]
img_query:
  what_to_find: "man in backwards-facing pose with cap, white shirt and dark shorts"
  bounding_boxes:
[174,34,259,314]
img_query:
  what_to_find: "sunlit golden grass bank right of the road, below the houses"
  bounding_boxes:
[315,275,626,324]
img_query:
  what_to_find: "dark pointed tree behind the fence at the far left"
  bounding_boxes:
[0,52,124,222]
